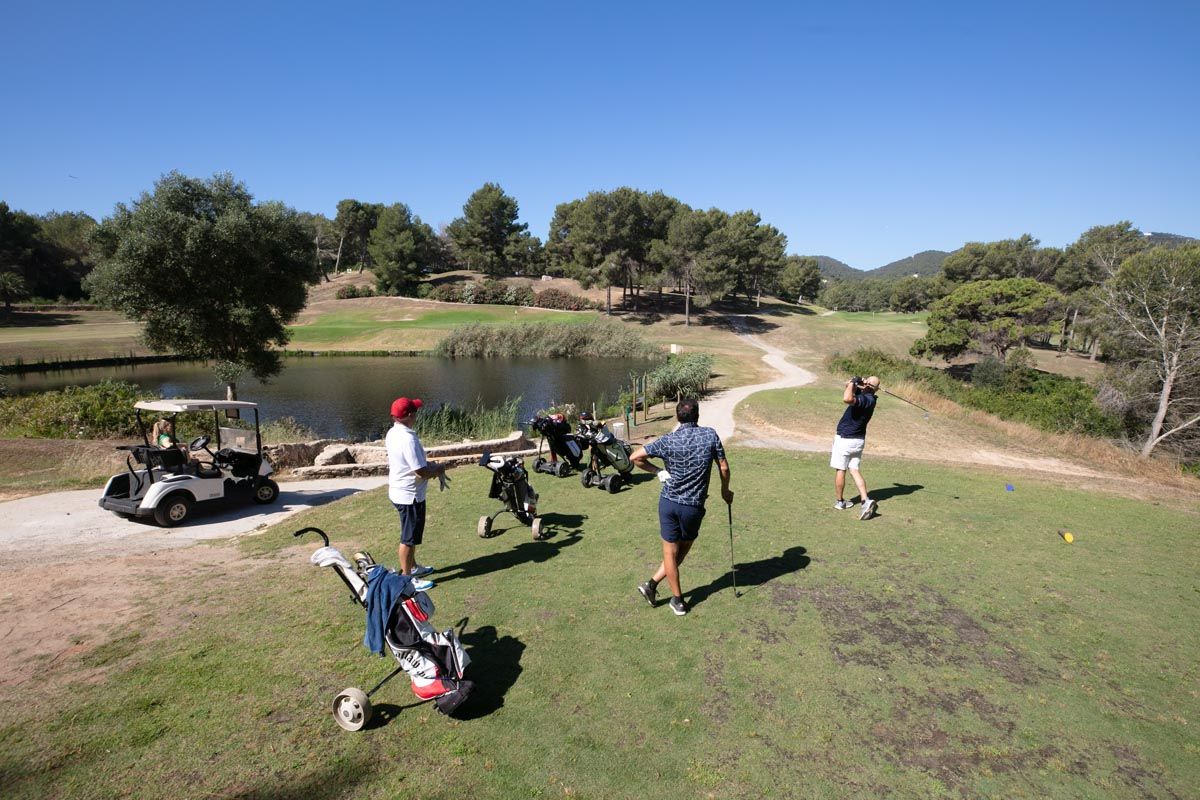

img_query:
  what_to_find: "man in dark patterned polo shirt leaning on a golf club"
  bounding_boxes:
[630,399,733,616]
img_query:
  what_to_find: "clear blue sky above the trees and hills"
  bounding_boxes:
[0,0,1200,269]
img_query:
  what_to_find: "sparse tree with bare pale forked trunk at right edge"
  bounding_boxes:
[1099,245,1200,456]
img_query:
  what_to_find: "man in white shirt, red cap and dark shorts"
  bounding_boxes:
[385,397,445,591]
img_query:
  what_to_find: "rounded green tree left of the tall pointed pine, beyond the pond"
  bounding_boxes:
[368,203,445,295]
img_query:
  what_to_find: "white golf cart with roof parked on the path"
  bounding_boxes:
[100,399,280,528]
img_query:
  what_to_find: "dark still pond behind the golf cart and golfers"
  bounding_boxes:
[6,356,650,440]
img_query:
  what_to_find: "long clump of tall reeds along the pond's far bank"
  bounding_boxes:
[436,319,656,359]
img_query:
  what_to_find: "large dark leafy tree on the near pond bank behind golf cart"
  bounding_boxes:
[88,173,314,399]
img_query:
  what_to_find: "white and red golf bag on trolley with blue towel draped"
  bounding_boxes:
[293,528,474,730]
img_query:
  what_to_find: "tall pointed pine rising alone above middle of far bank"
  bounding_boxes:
[446,184,541,276]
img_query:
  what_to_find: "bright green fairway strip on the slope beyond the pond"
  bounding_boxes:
[288,306,596,349]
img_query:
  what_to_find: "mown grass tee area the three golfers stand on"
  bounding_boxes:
[0,450,1200,799]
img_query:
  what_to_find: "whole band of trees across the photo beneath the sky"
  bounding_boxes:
[0,173,1200,455]
